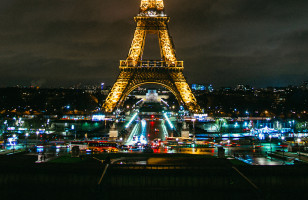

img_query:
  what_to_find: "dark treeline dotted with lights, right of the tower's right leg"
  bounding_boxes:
[197,89,308,119]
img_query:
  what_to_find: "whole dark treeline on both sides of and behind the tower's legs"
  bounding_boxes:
[0,88,308,119]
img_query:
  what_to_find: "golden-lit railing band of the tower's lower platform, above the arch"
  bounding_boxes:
[120,60,184,67]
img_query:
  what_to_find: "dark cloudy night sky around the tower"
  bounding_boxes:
[0,0,308,87]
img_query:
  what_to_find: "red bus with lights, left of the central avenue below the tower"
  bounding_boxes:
[87,141,119,153]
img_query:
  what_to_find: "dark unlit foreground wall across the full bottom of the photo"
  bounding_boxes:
[0,156,308,200]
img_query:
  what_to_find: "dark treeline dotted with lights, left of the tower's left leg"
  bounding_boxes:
[0,88,105,114]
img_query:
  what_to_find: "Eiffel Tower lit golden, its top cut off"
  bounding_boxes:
[103,0,201,113]
